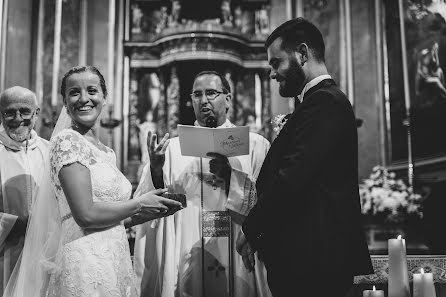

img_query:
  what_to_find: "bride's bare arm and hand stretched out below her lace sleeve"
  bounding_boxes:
[59,162,181,228]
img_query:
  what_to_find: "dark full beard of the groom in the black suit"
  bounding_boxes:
[279,59,305,97]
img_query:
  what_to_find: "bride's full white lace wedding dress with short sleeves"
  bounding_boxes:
[47,129,136,297]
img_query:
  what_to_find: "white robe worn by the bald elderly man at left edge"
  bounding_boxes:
[0,125,49,292]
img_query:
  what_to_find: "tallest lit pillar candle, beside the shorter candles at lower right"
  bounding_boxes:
[388,235,410,297]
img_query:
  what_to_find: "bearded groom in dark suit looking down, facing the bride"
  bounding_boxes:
[237,18,373,297]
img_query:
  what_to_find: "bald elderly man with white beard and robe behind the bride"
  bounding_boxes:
[0,86,49,292]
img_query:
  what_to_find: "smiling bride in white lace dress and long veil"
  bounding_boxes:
[4,66,181,297]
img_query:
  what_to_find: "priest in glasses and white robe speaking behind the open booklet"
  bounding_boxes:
[134,71,271,297]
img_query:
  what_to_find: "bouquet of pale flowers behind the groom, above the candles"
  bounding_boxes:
[359,166,423,223]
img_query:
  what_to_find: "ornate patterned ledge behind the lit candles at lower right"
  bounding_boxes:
[354,255,446,284]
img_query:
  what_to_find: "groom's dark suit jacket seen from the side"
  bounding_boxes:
[243,79,373,278]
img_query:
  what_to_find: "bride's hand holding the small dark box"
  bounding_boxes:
[136,189,182,219]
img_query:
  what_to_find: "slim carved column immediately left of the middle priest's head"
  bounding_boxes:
[167,67,180,137]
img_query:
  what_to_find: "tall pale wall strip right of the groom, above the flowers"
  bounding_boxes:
[350,1,384,178]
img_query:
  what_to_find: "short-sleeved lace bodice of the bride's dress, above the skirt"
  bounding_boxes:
[50,129,132,243]
